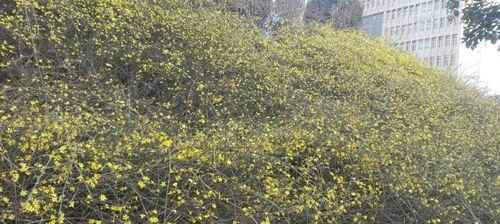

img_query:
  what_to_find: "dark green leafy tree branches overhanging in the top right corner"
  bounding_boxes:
[448,0,500,51]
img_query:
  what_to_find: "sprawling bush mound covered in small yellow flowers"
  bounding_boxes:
[0,0,500,223]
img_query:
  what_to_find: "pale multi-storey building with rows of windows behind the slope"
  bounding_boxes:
[361,0,468,73]
